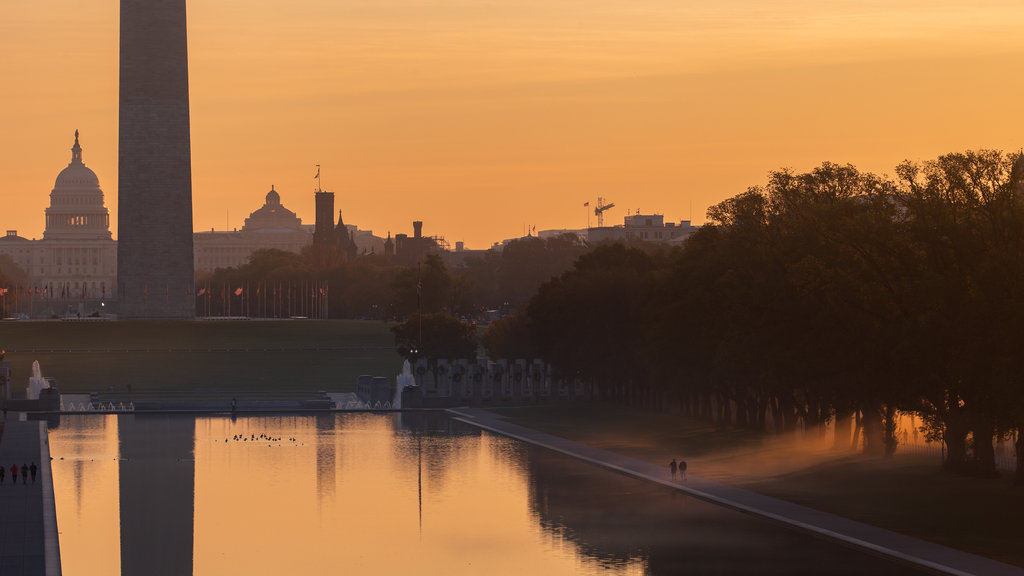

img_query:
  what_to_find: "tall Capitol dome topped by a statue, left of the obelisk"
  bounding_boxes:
[43,130,111,240]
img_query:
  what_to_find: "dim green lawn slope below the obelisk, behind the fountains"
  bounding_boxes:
[0,320,401,393]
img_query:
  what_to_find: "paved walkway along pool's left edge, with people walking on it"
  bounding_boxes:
[0,412,60,576]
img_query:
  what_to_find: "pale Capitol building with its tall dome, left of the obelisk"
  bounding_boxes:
[0,130,118,315]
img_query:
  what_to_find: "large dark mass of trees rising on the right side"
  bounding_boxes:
[482,151,1024,483]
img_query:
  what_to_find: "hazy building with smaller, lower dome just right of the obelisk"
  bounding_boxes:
[193,186,313,272]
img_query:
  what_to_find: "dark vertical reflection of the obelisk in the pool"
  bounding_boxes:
[118,414,196,576]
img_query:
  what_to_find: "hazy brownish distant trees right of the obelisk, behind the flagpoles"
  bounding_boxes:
[196,229,587,321]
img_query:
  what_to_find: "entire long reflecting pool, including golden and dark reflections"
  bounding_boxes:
[49,413,929,576]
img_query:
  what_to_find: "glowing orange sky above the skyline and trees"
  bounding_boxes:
[0,0,1024,248]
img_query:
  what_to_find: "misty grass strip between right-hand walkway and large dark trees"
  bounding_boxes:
[495,404,1024,567]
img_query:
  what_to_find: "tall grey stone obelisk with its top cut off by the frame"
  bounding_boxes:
[118,0,196,318]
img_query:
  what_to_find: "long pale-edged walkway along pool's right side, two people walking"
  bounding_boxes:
[449,408,1024,576]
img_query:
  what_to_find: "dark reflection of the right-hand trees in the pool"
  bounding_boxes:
[527,448,933,576]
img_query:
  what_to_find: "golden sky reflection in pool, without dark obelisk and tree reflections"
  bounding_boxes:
[50,414,643,576]
